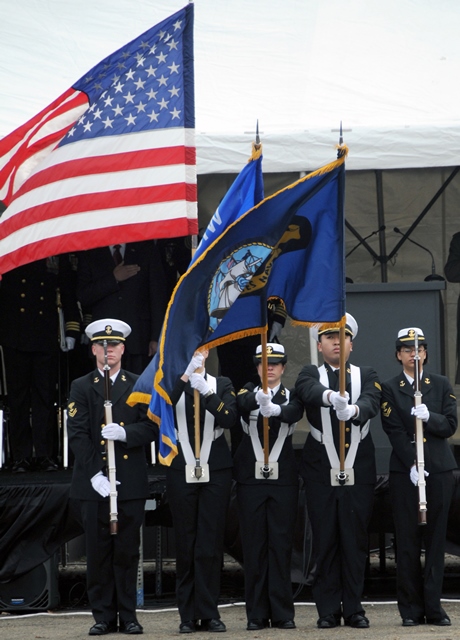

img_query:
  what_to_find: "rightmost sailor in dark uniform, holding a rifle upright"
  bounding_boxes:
[382,327,457,627]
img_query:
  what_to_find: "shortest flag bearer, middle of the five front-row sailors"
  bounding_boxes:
[233,343,303,631]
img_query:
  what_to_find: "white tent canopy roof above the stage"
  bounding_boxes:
[0,0,460,174]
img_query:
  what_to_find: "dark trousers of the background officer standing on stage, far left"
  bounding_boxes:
[3,346,58,460]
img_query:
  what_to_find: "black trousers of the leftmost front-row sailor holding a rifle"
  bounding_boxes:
[79,499,145,624]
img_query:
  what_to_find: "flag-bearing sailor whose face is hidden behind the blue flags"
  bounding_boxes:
[165,350,238,633]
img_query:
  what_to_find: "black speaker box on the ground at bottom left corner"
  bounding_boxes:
[0,555,59,612]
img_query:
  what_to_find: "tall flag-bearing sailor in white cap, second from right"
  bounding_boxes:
[295,313,381,629]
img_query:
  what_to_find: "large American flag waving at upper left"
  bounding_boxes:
[0,3,198,274]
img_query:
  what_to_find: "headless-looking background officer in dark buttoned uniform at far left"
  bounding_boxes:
[0,255,80,473]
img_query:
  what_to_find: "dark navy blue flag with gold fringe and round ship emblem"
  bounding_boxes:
[155,154,345,402]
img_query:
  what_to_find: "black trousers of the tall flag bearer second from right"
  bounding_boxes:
[305,480,374,619]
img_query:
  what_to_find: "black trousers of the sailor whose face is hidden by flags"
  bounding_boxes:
[166,467,232,622]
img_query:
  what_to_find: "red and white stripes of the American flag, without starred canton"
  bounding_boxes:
[0,90,198,274]
